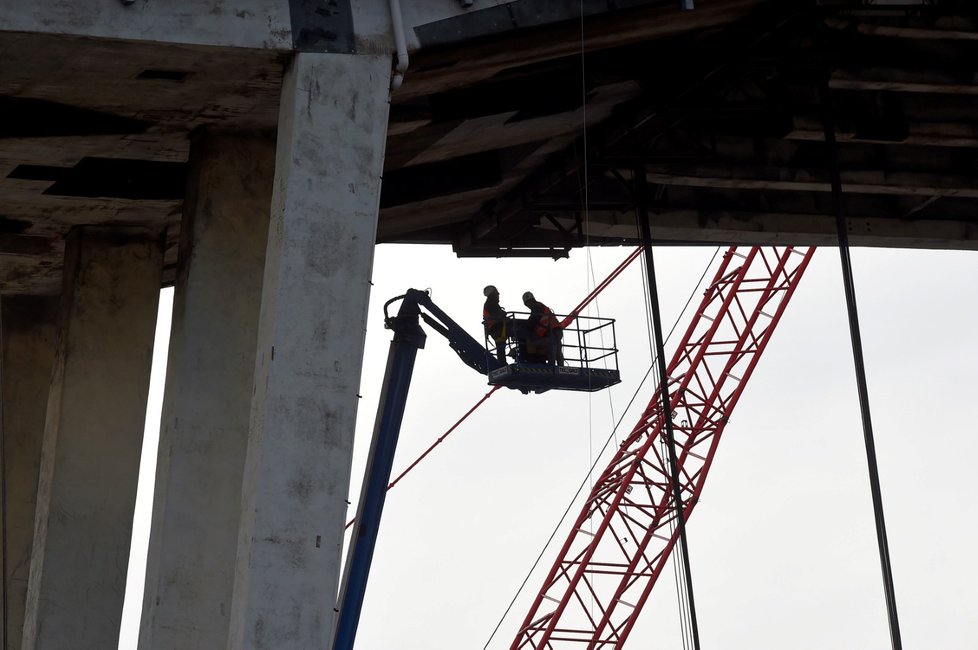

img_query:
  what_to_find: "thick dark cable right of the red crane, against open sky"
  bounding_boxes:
[819,84,903,650]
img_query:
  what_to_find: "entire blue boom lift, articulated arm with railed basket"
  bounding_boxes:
[332,289,621,650]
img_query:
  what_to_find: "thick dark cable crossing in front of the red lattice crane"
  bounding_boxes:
[633,165,700,650]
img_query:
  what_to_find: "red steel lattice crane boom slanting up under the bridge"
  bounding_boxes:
[510,247,815,650]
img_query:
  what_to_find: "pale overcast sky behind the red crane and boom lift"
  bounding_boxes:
[120,240,978,650]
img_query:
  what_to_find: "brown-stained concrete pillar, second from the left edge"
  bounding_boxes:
[23,228,162,650]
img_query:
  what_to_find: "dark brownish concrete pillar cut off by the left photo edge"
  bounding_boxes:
[0,296,58,650]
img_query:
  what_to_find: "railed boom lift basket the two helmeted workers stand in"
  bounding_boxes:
[486,312,621,393]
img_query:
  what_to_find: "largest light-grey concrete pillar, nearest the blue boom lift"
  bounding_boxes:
[228,54,391,650]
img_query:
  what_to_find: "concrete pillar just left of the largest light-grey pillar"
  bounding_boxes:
[139,132,275,650]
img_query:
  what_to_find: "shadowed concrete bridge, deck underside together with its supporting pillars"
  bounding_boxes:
[0,0,978,649]
